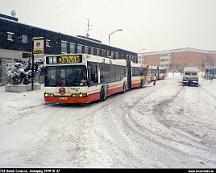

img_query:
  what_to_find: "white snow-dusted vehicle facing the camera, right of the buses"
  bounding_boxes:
[182,67,199,86]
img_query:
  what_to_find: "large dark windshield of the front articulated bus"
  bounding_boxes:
[45,65,87,87]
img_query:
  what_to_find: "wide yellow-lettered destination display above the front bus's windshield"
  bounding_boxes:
[57,55,82,64]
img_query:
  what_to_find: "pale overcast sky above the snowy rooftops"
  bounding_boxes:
[0,0,216,52]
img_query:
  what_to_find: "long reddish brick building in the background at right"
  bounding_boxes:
[139,48,216,71]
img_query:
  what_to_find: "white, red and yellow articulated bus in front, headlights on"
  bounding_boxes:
[44,54,148,103]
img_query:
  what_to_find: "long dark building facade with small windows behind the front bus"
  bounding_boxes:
[0,14,138,85]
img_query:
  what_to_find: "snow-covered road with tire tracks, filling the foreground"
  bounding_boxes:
[0,76,216,168]
